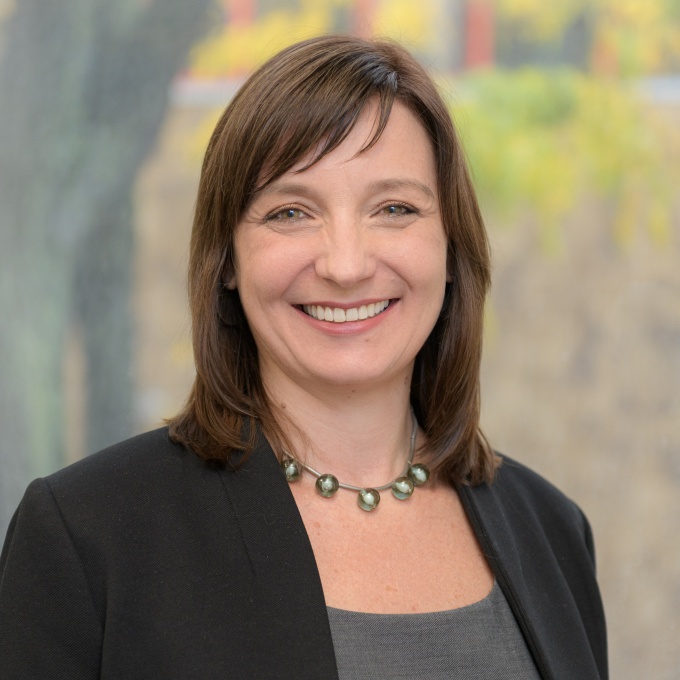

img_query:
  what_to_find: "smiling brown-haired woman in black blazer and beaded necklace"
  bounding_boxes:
[0,37,607,680]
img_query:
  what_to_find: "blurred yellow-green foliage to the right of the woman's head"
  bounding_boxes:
[462,0,680,250]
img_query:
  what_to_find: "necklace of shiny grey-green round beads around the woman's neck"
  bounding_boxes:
[281,412,430,512]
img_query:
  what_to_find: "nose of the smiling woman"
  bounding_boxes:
[316,217,376,288]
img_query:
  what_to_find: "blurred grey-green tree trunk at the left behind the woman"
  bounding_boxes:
[0,0,212,535]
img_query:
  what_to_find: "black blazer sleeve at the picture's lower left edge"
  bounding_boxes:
[0,479,103,680]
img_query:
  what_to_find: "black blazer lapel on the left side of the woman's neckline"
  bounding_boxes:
[222,430,338,680]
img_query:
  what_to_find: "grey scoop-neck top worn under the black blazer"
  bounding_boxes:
[328,583,540,680]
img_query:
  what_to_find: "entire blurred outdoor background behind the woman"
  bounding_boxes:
[0,0,680,680]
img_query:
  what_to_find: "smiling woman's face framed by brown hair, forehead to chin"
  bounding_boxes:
[230,103,447,396]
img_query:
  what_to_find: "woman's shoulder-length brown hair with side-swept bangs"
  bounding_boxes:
[169,36,496,484]
